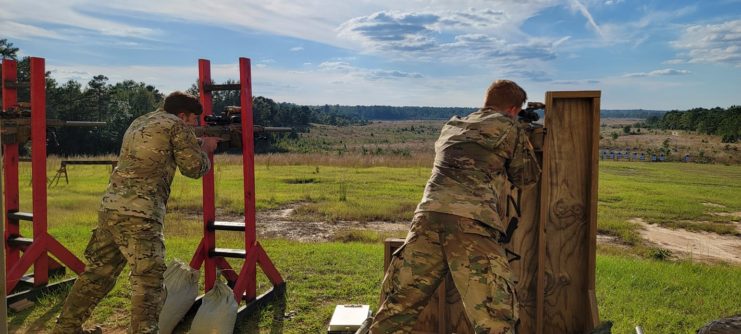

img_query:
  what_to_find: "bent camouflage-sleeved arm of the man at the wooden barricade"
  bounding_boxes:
[505,125,540,188]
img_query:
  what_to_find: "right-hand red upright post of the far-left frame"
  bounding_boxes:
[31,57,49,286]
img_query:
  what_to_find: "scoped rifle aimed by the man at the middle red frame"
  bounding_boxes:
[193,106,293,148]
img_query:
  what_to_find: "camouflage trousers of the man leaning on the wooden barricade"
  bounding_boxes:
[370,212,518,334]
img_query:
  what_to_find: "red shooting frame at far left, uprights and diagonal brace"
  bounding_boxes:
[2,57,85,292]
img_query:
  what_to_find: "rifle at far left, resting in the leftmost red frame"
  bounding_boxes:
[0,106,106,145]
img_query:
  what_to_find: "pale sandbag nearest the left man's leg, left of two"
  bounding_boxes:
[159,260,200,334]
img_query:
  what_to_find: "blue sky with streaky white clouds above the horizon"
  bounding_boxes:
[0,0,741,110]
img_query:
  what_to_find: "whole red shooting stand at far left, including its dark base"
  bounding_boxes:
[0,57,85,304]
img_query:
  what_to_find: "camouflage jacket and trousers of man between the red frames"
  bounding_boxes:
[53,109,210,333]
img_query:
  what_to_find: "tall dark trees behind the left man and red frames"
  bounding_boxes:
[0,39,363,155]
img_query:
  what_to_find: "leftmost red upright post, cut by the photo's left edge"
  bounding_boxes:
[2,59,21,272]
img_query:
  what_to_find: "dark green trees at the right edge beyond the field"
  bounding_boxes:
[640,106,741,143]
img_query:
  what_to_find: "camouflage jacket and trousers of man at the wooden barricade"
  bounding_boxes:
[371,108,540,333]
